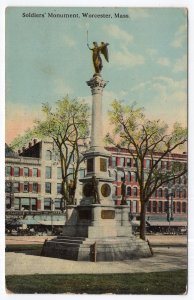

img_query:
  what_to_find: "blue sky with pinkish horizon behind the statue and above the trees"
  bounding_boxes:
[5,7,187,142]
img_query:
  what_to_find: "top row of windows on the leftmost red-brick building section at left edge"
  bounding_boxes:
[5,166,40,177]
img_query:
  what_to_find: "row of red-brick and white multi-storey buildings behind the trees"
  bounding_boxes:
[5,140,188,232]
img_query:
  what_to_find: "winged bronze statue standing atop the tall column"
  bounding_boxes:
[87,42,109,74]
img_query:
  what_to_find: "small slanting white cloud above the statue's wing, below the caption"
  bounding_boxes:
[103,24,133,44]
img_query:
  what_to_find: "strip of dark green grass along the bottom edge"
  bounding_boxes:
[6,270,187,295]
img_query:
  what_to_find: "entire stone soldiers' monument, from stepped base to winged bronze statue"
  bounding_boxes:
[42,42,151,261]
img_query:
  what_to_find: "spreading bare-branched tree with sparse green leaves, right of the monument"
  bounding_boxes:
[106,100,187,240]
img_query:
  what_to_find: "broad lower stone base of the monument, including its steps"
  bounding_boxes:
[43,205,151,261]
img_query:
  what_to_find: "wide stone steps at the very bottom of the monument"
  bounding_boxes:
[42,236,150,261]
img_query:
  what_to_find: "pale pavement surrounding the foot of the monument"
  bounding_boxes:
[5,236,187,275]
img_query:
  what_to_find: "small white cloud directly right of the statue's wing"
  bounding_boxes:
[111,48,145,68]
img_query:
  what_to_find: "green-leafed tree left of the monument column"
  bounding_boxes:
[34,96,89,204]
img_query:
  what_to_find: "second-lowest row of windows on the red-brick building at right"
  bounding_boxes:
[113,186,187,198]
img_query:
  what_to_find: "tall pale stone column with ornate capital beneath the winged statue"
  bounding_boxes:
[87,74,108,151]
